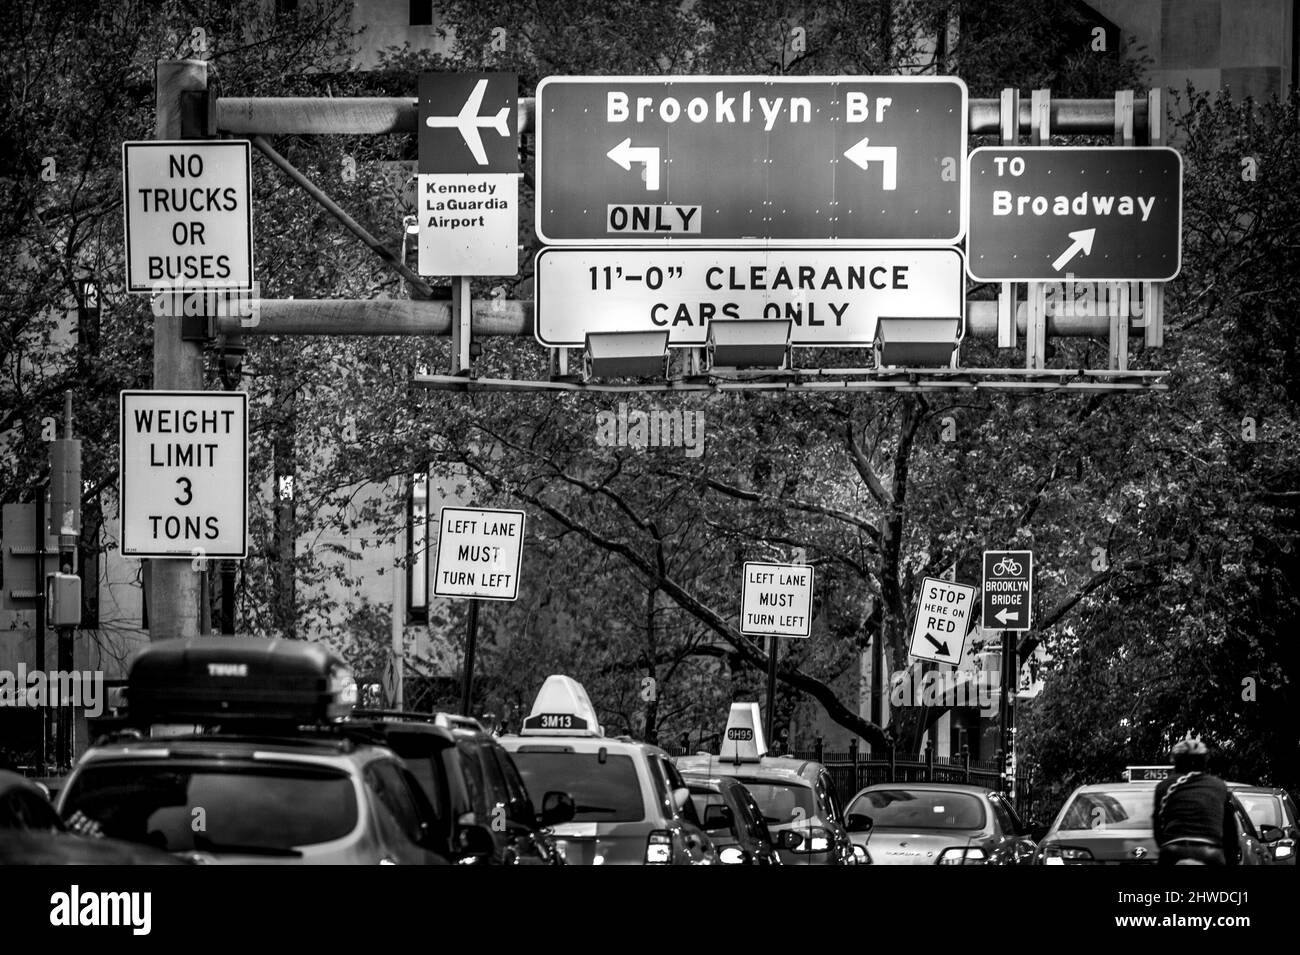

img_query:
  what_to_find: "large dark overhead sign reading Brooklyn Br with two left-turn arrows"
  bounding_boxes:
[537,77,967,246]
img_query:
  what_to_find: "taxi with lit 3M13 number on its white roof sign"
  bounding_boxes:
[501,674,718,865]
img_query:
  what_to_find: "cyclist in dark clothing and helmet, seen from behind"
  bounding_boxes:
[1153,738,1242,865]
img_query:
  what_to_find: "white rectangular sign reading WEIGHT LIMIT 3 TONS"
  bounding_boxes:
[120,391,248,557]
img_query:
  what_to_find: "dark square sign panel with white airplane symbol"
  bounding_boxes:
[417,73,519,173]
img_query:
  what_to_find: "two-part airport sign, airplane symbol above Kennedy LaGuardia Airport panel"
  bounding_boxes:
[416,73,519,275]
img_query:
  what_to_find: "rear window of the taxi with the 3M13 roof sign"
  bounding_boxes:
[511,748,646,822]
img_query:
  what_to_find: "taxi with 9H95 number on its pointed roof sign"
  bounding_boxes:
[675,702,858,865]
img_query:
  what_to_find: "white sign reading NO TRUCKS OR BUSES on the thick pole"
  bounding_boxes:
[122,140,254,292]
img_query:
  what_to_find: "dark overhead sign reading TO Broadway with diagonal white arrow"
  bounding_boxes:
[967,146,1183,282]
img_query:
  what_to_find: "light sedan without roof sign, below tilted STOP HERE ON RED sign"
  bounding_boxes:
[848,782,1037,865]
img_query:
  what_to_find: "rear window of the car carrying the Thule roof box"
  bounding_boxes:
[62,761,358,854]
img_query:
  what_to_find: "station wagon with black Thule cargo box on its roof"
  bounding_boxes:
[59,637,452,864]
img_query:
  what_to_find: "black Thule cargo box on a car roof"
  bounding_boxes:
[126,637,356,726]
